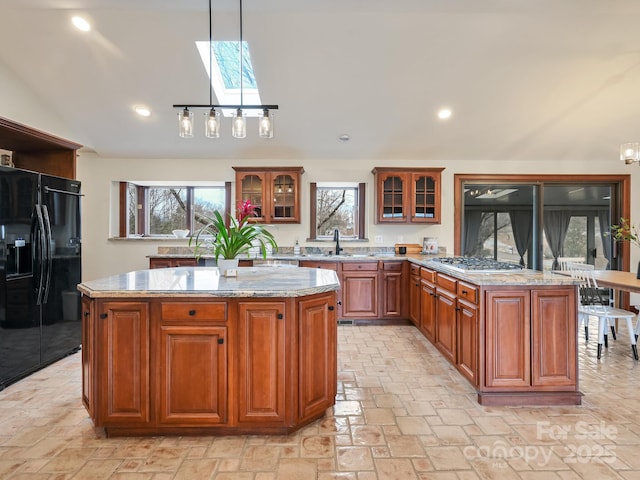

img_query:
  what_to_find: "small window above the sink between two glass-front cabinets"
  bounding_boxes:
[309,182,365,240]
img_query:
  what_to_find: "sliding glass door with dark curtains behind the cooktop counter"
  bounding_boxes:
[459,179,620,270]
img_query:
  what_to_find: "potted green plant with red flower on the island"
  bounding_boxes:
[189,200,278,273]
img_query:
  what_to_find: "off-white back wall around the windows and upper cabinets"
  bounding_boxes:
[77,153,640,280]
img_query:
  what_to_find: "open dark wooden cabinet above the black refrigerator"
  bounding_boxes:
[0,117,82,178]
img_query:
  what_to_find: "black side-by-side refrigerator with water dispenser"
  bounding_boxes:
[0,167,82,390]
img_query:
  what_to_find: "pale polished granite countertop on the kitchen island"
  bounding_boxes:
[78,267,340,298]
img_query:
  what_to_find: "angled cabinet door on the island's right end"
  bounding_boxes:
[297,293,337,420]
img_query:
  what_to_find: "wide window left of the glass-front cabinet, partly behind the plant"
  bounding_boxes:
[120,182,231,237]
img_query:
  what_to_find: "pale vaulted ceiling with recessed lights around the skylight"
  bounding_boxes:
[0,0,640,161]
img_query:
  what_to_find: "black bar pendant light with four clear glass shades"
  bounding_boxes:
[173,0,278,138]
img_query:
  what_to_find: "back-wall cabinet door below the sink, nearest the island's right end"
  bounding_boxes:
[342,266,378,318]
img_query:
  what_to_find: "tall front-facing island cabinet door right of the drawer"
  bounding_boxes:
[238,302,288,424]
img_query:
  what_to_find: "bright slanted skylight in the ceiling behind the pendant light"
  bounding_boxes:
[196,41,262,117]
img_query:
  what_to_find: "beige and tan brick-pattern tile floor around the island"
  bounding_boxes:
[0,326,640,480]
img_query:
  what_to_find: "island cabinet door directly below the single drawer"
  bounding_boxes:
[156,325,228,426]
